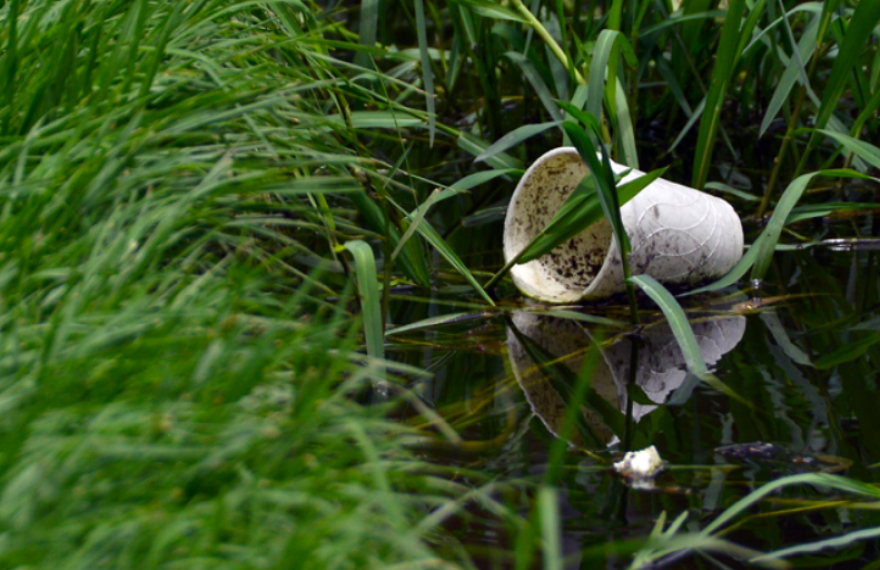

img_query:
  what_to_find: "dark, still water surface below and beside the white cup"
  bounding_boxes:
[389,214,880,568]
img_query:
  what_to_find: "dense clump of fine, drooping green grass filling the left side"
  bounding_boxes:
[0,0,468,569]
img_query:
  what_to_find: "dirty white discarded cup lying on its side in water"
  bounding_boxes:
[504,147,743,303]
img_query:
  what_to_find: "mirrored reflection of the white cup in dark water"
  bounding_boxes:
[507,311,746,447]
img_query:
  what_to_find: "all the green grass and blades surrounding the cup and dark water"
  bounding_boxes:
[0,0,880,569]
